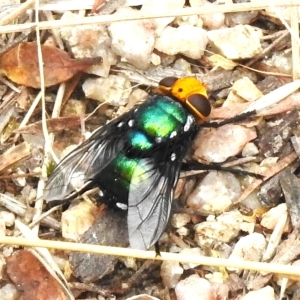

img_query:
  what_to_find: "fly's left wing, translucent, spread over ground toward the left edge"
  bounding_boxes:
[43,112,132,202]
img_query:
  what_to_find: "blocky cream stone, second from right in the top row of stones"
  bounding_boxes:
[155,25,207,59]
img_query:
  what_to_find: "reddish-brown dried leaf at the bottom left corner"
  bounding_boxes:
[6,250,66,300]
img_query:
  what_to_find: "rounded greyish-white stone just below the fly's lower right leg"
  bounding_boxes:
[187,171,242,216]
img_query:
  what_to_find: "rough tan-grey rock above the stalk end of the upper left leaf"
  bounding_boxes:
[59,11,117,77]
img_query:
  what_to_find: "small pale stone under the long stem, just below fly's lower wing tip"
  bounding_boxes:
[160,260,183,289]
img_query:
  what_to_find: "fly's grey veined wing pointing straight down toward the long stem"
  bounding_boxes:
[127,158,181,250]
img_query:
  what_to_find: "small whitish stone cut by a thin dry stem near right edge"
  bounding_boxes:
[260,203,291,233]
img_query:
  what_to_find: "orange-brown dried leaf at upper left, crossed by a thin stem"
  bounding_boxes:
[0,42,102,88]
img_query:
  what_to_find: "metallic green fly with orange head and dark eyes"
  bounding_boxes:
[44,77,244,249]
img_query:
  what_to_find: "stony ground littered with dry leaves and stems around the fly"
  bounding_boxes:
[0,0,300,300]
